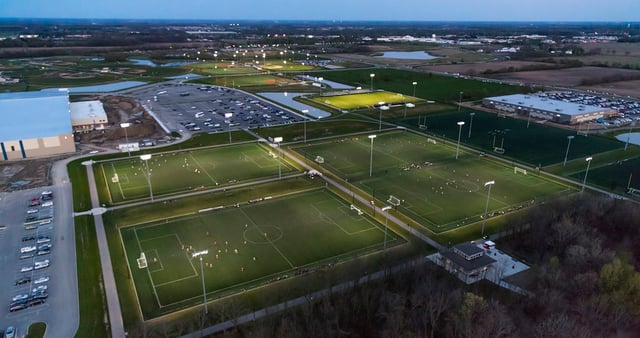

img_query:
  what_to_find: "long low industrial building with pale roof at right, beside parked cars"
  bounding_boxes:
[482,94,618,124]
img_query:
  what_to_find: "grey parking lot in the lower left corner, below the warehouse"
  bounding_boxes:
[0,188,77,336]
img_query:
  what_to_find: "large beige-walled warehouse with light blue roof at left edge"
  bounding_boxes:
[0,89,76,161]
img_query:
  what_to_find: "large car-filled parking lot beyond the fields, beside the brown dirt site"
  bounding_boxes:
[132,82,305,133]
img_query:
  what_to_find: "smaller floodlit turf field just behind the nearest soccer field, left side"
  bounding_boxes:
[94,143,296,203]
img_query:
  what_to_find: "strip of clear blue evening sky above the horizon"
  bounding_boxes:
[0,0,640,22]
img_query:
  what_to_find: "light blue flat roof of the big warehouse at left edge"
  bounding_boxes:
[0,89,72,141]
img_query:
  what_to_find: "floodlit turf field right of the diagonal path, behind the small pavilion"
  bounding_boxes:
[296,132,572,232]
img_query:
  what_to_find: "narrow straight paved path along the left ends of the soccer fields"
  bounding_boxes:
[86,165,125,337]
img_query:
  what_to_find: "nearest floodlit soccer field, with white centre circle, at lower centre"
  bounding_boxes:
[120,188,401,319]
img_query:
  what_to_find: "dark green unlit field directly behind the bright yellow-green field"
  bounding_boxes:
[314,69,531,102]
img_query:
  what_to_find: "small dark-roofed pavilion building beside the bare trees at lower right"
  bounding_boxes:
[436,243,496,284]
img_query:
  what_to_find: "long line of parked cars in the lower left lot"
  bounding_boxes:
[9,191,53,312]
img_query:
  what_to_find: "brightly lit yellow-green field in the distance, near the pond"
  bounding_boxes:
[313,91,419,109]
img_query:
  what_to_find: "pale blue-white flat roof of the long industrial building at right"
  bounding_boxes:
[485,94,608,115]
